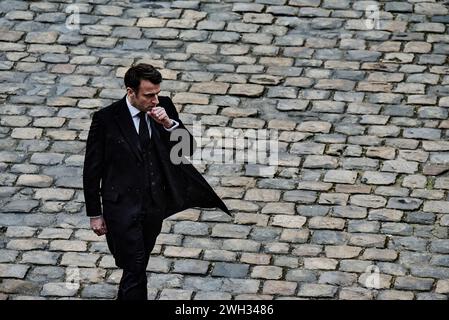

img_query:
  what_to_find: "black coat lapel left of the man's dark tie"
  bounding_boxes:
[114,97,143,161]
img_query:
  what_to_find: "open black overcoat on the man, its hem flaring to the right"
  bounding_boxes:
[83,97,229,221]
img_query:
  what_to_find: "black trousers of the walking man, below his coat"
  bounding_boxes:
[117,207,163,300]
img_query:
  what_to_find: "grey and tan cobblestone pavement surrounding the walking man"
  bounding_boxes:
[0,0,449,299]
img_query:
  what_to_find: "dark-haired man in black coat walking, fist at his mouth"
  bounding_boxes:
[83,64,229,300]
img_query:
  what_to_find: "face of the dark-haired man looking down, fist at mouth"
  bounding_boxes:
[127,80,161,112]
